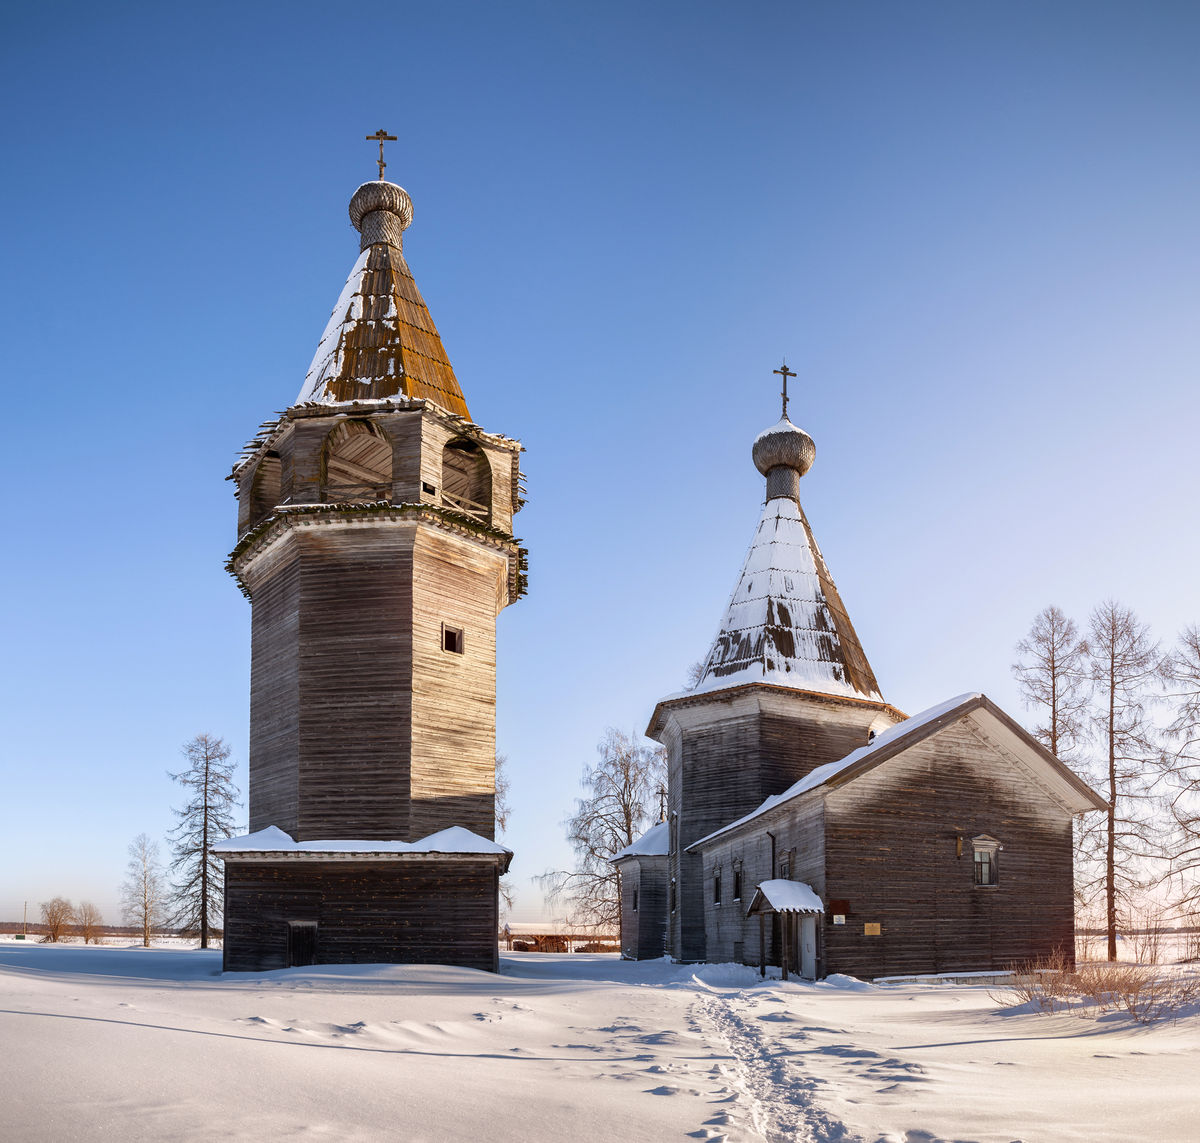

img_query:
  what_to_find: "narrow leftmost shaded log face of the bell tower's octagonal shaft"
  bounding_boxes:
[248,545,300,833]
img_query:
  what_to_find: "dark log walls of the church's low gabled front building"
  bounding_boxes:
[696,700,1099,979]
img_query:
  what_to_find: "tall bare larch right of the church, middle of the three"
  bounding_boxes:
[1084,599,1163,961]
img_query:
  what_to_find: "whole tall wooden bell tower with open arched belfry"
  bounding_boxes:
[214,156,526,970]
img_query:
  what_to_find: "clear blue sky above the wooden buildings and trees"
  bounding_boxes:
[0,0,1200,920]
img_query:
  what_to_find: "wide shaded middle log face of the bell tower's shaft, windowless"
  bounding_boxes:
[292,522,424,840]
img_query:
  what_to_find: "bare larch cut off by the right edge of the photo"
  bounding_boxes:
[1163,626,1200,915]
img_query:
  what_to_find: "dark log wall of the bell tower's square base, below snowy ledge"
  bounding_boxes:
[224,861,498,971]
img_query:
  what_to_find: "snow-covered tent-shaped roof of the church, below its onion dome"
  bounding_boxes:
[689,496,882,701]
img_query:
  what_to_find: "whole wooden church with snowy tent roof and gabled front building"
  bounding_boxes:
[613,389,1105,979]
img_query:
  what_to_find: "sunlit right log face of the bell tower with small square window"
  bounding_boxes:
[410,528,508,838]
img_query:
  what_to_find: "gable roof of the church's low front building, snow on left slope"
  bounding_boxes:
[688,692,1108,850]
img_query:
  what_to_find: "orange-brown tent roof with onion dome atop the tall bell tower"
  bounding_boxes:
[295,181,470,420]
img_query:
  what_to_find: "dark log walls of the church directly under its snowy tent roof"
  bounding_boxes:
[647,683,902,961]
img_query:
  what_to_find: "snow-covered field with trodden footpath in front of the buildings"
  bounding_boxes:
[0,939,1200,1143]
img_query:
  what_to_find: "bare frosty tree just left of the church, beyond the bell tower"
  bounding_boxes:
[541,728,666,926]
